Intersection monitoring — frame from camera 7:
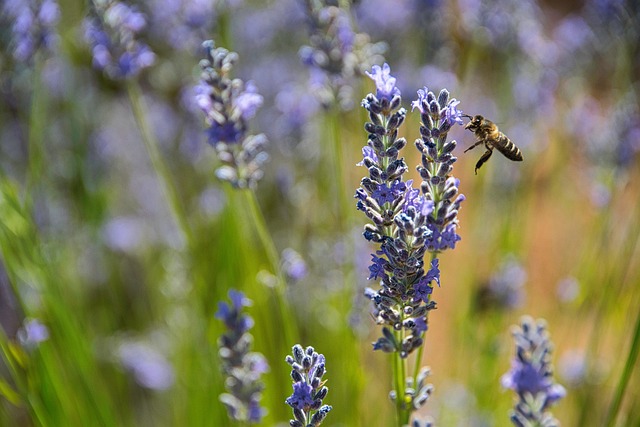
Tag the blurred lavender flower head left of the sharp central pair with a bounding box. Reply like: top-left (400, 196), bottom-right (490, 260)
top-left (195, 40), bottom-right (269, 188)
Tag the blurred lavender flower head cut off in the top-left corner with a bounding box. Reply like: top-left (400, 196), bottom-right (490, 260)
top-left (1, 0), bottom-right (60, 63)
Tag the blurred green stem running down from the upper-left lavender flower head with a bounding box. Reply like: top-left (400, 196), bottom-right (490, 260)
top-left (127, 80), bottom-right (193, 246)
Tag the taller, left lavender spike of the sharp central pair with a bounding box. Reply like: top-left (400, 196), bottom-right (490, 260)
top-left (356, 64), bottom-right (440, 358)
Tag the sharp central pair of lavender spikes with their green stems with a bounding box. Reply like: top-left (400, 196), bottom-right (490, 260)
top-left (355, 64), bottom-right (464, 426)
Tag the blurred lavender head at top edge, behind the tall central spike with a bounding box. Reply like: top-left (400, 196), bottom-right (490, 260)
top-left (300, 0), bottom-right (386, 109)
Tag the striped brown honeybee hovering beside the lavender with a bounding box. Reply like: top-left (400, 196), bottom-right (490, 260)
top-left (463, 114), bottom-right (522, 175)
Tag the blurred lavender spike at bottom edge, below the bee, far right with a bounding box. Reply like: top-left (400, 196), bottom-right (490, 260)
top-left (501, 316), bottom-right (566, 427)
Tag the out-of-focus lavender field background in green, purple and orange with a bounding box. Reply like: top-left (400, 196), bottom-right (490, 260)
top-left (0, 0), bottom-right (640, 426)
